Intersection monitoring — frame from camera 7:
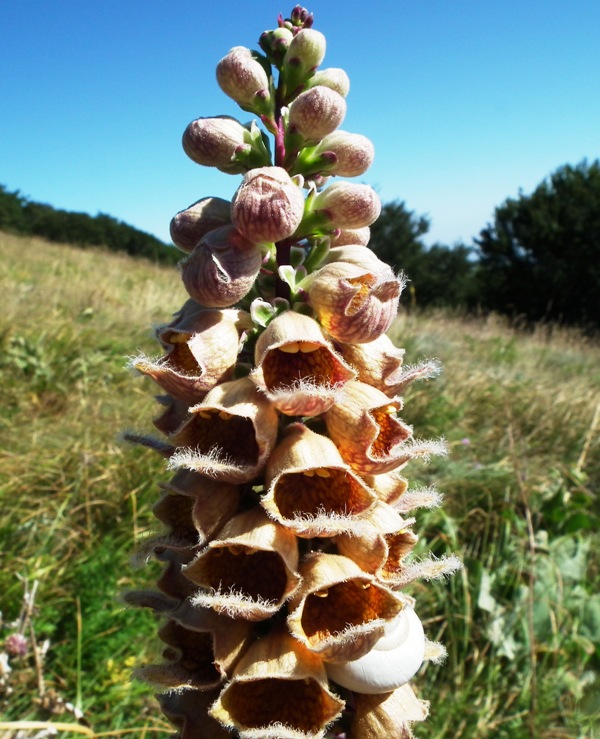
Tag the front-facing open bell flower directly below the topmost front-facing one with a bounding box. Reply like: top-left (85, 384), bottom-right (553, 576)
top-left (261, 423), bottom-right (376, 538)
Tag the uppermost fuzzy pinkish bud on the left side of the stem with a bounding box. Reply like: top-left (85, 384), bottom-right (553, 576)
top-left (217, 46), bottom-right (272, 113)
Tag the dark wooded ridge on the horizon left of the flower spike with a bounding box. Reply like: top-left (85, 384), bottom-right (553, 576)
top-left (0, 185), bottom-right (182, 264)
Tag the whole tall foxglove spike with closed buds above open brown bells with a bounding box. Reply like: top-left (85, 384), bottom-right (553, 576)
top-left (127, 6), bottom-right (459, 739)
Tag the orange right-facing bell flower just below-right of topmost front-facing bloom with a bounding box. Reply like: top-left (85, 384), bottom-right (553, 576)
top-left (325, 380), bottom-right (412, 475)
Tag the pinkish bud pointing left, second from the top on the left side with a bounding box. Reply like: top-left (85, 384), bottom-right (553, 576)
top-left (182, 115), bottom-right (252, 174)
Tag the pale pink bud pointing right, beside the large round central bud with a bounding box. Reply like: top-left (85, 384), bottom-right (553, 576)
top-left (311, 182), bottom-right (381, 228)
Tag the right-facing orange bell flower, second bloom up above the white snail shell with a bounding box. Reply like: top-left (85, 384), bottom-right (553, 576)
top-left (335, 502), bottom-right (418, 585)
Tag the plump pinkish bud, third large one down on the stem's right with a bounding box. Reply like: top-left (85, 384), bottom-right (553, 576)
top-left (289, 86), bottom-right (346, 142)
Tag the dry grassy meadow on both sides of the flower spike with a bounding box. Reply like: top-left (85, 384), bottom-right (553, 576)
top-left (0, 234), bottom-right (600, 739)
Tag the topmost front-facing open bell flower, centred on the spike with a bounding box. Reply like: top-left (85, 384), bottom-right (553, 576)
top-left (250, 311), bottom-right (356, 416)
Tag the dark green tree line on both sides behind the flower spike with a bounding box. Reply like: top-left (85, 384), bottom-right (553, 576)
top-left (0, 160), bottom-right (600, 330)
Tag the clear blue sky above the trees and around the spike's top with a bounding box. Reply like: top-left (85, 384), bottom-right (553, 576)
top-left (0, 0), bottom-right (600, 245)
